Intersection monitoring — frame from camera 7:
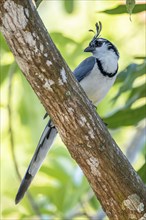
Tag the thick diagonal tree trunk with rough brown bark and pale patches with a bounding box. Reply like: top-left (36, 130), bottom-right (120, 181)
top-left (0, 0), bottom-right (146, 220)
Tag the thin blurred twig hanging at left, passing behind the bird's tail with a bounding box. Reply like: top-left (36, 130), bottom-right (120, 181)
top-left (7, 62), bottom-right (41, 219)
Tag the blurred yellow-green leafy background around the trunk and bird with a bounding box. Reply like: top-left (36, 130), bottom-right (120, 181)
top-left (0, 0), bottom-right (146, 220)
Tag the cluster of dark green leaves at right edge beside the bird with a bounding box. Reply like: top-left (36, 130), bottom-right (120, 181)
top-left (105, 61), bottom-right (146, 129)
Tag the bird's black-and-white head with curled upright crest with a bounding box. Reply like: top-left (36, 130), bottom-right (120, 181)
top-left (84, 22), bottom-right (119, 59)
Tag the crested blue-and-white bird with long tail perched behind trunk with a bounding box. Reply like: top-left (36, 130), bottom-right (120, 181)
top-left (15, 21), bottom-right (119, 204)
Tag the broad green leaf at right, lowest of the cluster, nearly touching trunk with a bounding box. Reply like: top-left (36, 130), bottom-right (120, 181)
top-left (104, 105), bottom-right (146, 129)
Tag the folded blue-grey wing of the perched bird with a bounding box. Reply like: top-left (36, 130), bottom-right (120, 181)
top-left (73, 57), bottom-right (96, 82)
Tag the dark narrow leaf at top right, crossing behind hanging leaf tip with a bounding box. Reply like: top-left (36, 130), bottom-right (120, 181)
top-left (101, 4), bottom-right (146, 15)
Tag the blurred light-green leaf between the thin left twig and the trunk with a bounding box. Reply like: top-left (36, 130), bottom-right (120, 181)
top-left (18, 74), bottom-right (46, 143)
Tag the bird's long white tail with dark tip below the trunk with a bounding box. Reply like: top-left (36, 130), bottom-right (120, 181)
top-left (15, 120), bottom-right (57, 204)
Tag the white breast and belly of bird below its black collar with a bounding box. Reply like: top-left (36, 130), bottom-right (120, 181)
top-left (80, 65), bottom-right (116, 105)
